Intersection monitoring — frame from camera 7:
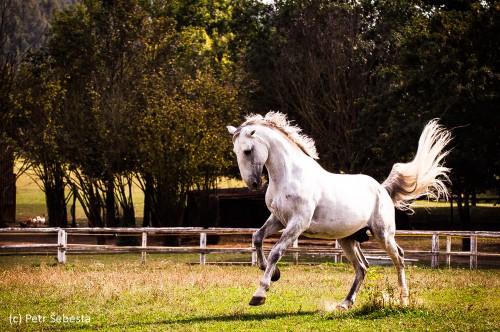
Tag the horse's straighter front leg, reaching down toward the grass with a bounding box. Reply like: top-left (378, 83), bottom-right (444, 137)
top-left (249, 223), bottom-right (305, 305)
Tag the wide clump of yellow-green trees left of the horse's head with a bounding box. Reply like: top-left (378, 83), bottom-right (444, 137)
top-left (10, 0), bottom-right (246, 226)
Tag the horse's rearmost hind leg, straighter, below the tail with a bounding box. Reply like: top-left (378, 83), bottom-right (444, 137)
top-left (374, 232), bottom-right (409, 306)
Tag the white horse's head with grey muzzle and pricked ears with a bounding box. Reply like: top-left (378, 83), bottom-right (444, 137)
top-left (227, 126), bottom-right (269, 190)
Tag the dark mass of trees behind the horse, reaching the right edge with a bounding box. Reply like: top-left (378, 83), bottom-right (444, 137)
top-left (240, 0), bottom-right (500, 223)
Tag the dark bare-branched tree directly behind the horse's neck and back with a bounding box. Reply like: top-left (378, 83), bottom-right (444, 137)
top-left (246, 0), bottom-right (422, 176)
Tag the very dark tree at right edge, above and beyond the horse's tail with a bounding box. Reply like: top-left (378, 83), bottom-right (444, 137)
top-left (391, 1), bottom-right (500, 228)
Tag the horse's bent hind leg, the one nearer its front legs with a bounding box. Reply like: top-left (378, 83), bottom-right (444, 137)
top-left (337, 237), bottom-right (368, 309)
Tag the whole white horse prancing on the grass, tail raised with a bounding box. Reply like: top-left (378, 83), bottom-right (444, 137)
top-left (227, 112), bottom-right (451, 309)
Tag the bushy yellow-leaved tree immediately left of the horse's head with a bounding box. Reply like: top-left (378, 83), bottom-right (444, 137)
top-left (139, 63), bottom-right (238, 226)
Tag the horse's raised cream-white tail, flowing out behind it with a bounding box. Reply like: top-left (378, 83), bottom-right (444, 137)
top-left (382, 120), bottom-right (451, 211)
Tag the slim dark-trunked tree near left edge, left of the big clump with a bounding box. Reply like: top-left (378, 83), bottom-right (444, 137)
top-left (13, 56), bottom-right (68, 227)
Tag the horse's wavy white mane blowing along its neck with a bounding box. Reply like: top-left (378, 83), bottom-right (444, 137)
top-left (241, 112), bottom-right (319, 159)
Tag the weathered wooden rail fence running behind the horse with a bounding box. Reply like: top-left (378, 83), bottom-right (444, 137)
top-left (0, 227), bottom-right (500, 269)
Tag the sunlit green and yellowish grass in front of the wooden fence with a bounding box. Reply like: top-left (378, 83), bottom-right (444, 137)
top-left (0, 255), bottom-right (500, 331)
